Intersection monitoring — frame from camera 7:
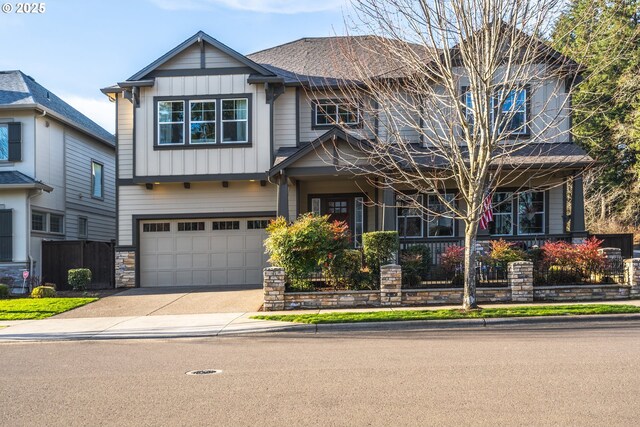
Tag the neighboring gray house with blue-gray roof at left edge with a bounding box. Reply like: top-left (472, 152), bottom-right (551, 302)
top-left (0, 71), bottom-right (116, 282)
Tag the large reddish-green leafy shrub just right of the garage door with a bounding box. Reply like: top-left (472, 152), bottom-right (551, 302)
top-left (265, 214), bottom-right (349, 290)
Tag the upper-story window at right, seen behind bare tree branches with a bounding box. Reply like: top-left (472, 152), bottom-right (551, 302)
top-left (463, 87), bottom-right (530, 135)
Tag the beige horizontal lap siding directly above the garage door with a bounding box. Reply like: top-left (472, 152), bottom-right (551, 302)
top-left (118, 181), bottom-right (278, 246)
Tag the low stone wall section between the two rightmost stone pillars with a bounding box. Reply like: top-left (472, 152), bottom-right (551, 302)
top-left (533, 285), bottom-right (630, 301)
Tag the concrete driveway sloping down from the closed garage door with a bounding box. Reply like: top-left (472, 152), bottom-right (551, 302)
top-left (56, 286), bottom-right (263, 319)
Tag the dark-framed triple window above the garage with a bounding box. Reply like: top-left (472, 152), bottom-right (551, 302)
top-left (155, 94), bottom-right (251, 149)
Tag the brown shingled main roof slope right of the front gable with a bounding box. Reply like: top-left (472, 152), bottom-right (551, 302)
top-left (247, 35), bottom-right (428, 86)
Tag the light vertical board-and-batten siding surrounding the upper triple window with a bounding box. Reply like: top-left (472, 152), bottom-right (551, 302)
top-left (135, 74), bottom-right (271, 176)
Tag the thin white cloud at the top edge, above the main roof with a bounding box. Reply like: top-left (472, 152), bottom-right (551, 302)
top-left (149, 0), bottom-right (347, 15)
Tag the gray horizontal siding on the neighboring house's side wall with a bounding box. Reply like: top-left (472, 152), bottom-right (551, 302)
top-left (65, 130), bottom-right (116, 240)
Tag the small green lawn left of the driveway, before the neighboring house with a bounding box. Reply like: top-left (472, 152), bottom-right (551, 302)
top-left (0, 298), bottom-right (98, 320)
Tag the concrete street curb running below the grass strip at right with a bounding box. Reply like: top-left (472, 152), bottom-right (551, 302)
top-left (261, 313), bottom-right (640, 333)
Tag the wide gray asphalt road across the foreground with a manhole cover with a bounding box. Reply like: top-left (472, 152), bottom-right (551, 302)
top-left (0, 321), bottom-right (640, 426)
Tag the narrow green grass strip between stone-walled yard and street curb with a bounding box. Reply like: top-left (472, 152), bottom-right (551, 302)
top-left (251, 304), bottom-right (640, 325)
